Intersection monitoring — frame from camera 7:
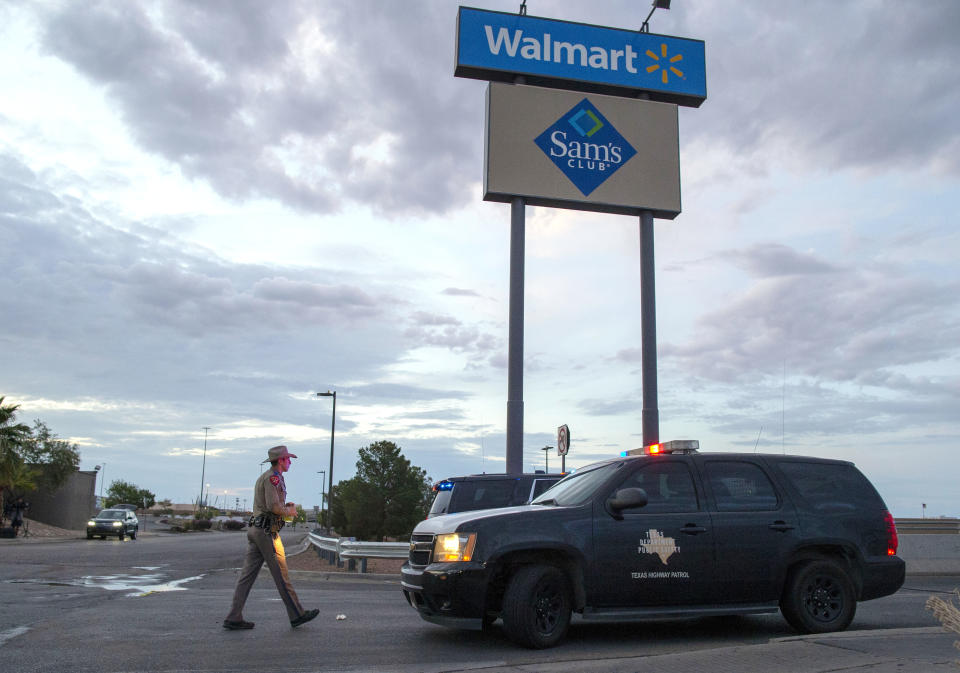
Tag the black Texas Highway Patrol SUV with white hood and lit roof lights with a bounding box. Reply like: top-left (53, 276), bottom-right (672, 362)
top-left (401, 440), bottom-right (905, 648)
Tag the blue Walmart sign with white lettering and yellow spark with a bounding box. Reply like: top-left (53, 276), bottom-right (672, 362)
top-left (454, 7), bottom-right (707, 107)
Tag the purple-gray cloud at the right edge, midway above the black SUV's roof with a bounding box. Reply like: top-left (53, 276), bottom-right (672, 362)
top-left (660, 246), bottom-right (960, 381)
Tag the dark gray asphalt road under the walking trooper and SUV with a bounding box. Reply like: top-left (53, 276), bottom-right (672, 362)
top-left (0, 531), bottom-right (960, 673)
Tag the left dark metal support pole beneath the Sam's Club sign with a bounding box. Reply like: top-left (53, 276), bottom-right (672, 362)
top-left (506, 196), bottom-right (526, 474)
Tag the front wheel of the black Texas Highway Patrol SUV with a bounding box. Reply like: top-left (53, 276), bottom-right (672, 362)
top-left (501, 565), bottom-right (571, 649)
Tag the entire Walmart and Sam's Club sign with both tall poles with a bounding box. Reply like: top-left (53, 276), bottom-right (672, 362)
top-left (454, 0), bottom-right (707, 473)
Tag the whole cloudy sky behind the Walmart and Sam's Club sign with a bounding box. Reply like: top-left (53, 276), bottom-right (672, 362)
top-left (0, 0), bottom-right (960, 516)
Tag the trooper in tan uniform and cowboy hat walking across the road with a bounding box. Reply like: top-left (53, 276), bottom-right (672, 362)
top-left (223, 446), bottom-right (320, 630)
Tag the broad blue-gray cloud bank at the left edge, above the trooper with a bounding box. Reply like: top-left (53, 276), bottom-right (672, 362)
top-left (0, 155), bottom-right (404, 406)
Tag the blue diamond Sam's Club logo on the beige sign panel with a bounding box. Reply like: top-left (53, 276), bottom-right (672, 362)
top-left (534, 98), bottom-right (637, 196)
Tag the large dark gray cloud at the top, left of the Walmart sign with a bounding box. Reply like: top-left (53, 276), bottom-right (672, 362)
top-left (37, 2), bottom-right (482, 214)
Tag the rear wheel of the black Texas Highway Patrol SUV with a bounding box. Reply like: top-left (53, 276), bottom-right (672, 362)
top-left (780, 561), bottom-right (857, 633)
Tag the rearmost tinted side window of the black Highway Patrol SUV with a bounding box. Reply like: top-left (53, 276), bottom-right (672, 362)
top-left (779, 461), bottom-right (884, 510)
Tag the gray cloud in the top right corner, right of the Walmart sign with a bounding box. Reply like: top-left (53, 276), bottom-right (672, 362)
top-left (680, 0), bottom-right (960, 174)
